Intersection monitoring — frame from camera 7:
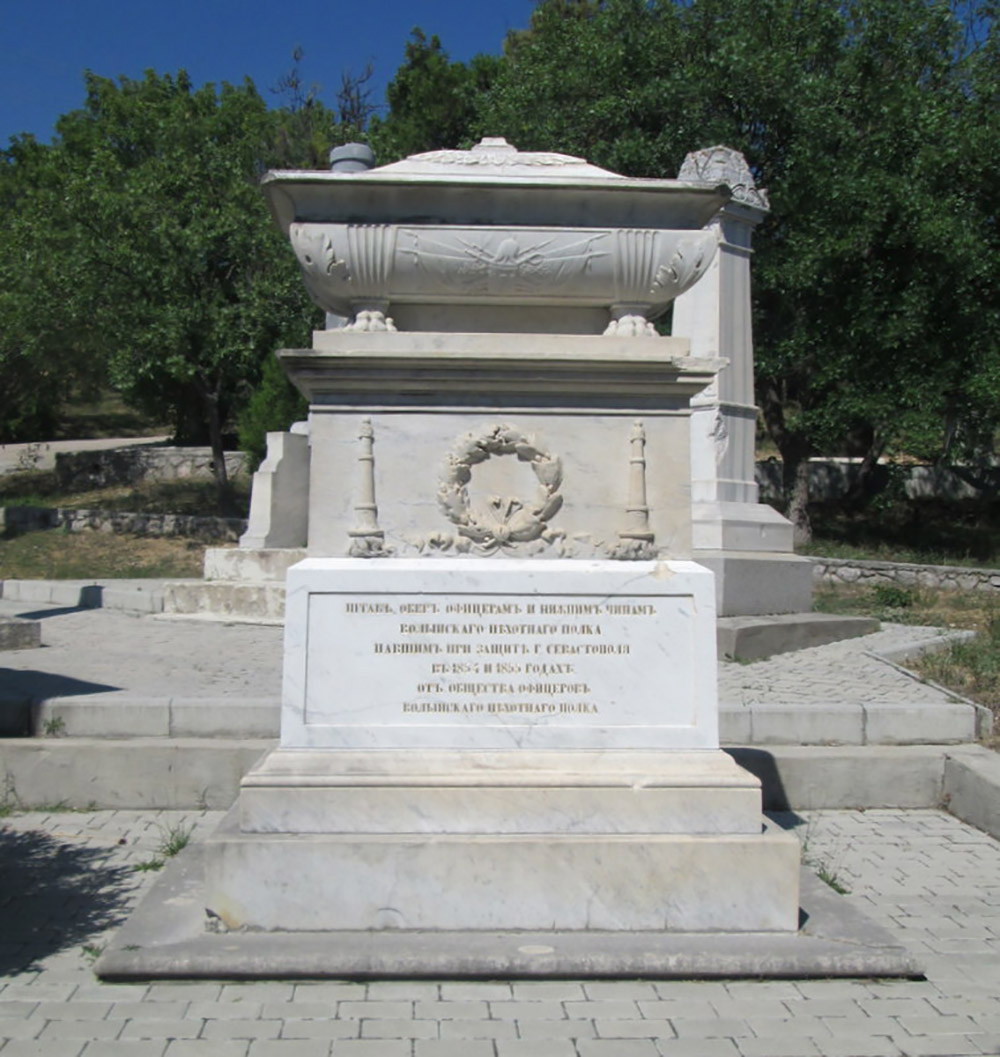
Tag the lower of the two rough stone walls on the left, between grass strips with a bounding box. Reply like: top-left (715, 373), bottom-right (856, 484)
top-left (0, 506), bottom-right (246, 542)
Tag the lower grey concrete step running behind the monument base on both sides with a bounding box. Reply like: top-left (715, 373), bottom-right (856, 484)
top-left (0, 737), bottom-right (1000, 811)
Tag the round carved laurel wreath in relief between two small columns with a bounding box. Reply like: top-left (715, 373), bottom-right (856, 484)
top-left (438, 426), bottom-right (562, 550)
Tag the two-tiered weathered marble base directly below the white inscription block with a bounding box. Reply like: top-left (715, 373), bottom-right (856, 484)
top-left (205, 749), bottom-right (799, 932)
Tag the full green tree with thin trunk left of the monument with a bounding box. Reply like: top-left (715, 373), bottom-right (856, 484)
top-left (46, 72), bottom-right (315, 503)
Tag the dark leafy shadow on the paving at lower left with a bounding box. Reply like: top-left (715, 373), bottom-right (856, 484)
top-left (0, 826), bottom-right (134, 975)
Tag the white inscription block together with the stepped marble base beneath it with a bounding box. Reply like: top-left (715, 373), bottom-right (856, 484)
top-left (205, 558), bottom-right (799, 932)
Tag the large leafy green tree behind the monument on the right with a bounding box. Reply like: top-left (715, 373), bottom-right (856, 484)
top-left (474, 0), bottom-right (1000, 535)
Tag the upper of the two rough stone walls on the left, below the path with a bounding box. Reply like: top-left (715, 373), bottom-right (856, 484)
top-left (55, 445), bottom-right (246, 490)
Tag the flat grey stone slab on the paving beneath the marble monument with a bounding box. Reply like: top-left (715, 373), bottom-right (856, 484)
top-left (96, 845), bottom-right (923, 981)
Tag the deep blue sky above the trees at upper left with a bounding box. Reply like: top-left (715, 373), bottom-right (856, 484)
top-left (0, 0), bottom-right (535, 147)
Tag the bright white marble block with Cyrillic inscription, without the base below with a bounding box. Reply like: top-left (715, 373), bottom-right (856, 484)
top-left (282, 562), bottom-right (716, 748)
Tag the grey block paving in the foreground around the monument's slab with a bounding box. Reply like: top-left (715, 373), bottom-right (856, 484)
top-left (0, 811), bottom-right (1000, 1057)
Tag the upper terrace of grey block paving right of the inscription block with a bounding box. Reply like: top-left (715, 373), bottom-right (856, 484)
top-left (719, 624), bottom-right (953, 705)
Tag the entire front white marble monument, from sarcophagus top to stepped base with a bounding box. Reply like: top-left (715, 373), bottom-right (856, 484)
top-left (205, 140), bottom-right (799, 951)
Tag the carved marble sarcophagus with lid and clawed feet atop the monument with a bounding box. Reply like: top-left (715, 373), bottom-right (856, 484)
top-left (263, 138), bottom-right (730, 335)
